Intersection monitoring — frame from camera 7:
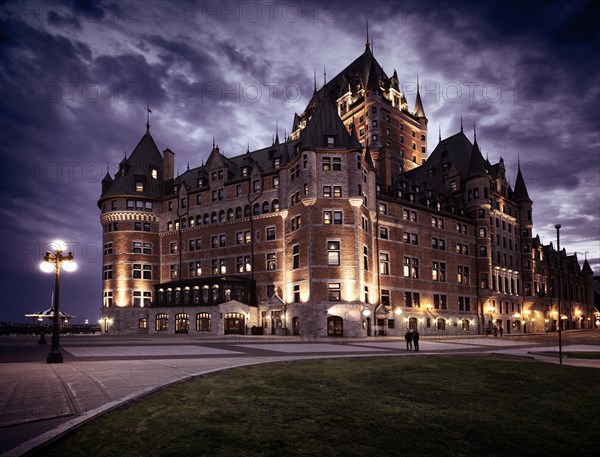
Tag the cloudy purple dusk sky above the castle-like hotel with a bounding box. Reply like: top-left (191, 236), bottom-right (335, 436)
top-left (0, 0), bottom-right (600, 323)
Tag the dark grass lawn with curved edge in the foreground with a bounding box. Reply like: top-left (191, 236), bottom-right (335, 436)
top-left (37, 356), bottom-right (600, 457)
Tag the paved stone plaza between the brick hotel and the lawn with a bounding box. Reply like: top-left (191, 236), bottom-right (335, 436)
top-left (0, 332), bottom-right (600, 456)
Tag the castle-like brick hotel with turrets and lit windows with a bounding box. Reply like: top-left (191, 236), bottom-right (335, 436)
top-left (98, 43), bottom-right (593, 338)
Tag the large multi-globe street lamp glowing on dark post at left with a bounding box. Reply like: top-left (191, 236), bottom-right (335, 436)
top-left (40, 241), bottom-right (77, 363)
